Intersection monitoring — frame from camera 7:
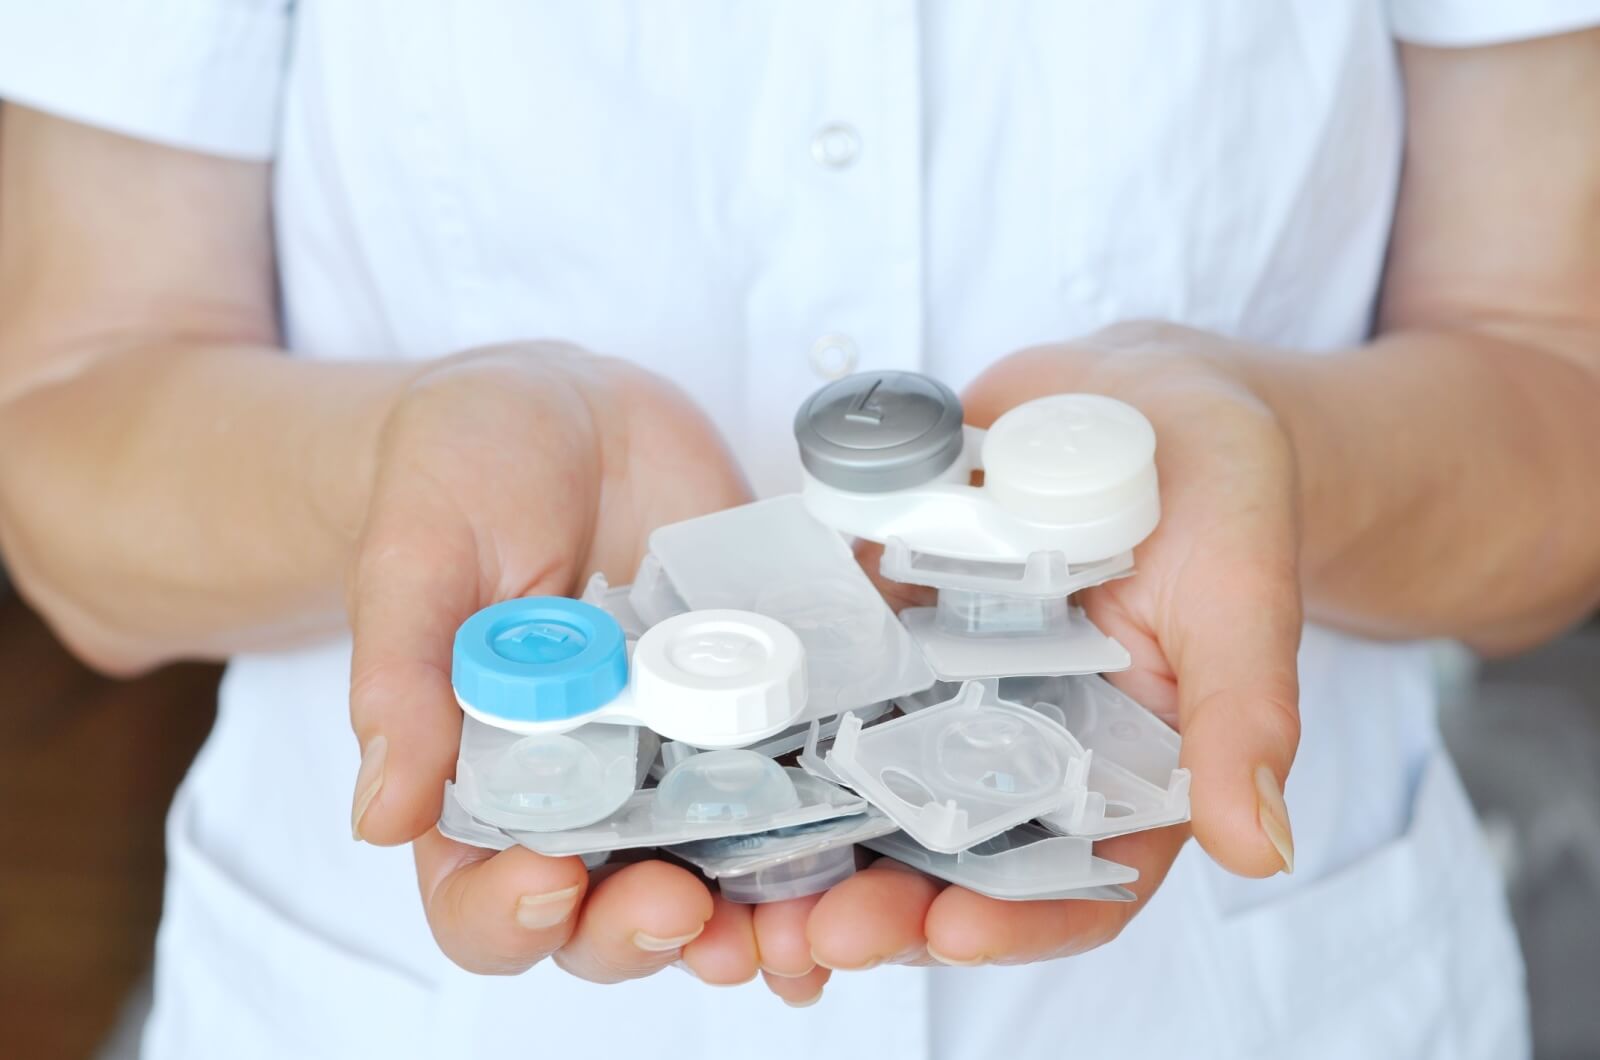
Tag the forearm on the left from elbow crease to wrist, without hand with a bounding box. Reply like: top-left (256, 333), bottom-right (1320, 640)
top-left (0, 341), bottom-right (408, 671)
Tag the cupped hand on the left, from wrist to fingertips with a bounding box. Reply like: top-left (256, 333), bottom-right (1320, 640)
top-left (349, 344), bottom-right (758, 983)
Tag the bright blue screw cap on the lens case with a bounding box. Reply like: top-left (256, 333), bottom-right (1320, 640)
top-left (450, 596), bottom-right (627, 722)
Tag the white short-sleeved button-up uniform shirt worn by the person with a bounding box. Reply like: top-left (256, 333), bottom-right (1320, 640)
top-left (0, 0), bottom-right (1600, 1060)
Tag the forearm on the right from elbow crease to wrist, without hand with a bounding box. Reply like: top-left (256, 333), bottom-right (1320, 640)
top-left (1240, 323), bottom-right (1600, 650)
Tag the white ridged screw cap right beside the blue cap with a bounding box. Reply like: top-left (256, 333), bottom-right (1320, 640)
top-left (632, 610), bottom-right (806, 748)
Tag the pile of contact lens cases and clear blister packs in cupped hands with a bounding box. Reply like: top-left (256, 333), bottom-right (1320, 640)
top-left (440, 371), bottom-right (1189, 901)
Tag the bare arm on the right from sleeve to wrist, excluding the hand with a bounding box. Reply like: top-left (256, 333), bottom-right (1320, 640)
top-left (1251, 30), bottom-right (1600, 650)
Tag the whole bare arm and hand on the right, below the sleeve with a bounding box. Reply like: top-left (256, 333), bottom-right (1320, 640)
top-left (806, 32), bottom-right (1600, 967)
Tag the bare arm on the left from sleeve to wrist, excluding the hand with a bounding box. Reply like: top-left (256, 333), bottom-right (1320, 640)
top-left (0, 107), bottom-right (406, 671)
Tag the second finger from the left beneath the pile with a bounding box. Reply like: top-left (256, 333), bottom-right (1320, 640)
top-left (554, 861), bottom-right (715, 983)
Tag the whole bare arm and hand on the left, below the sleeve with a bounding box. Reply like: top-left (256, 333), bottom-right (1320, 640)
top-left (0, 110), bottom-right (774, 982)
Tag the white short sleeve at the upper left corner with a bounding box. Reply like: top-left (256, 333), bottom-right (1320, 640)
top-left (0, 0), bottom-right (291, 160)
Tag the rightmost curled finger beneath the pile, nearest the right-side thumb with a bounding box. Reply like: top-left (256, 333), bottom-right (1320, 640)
top-left (925, 828), bottom-right (1187, 967)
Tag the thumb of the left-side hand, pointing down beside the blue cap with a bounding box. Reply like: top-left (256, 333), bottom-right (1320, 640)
top-left (350, 493), bottom-right (478, 844)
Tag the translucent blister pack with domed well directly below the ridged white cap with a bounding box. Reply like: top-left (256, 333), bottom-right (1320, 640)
top-left (512, 751), bottom-right (867, 857)
